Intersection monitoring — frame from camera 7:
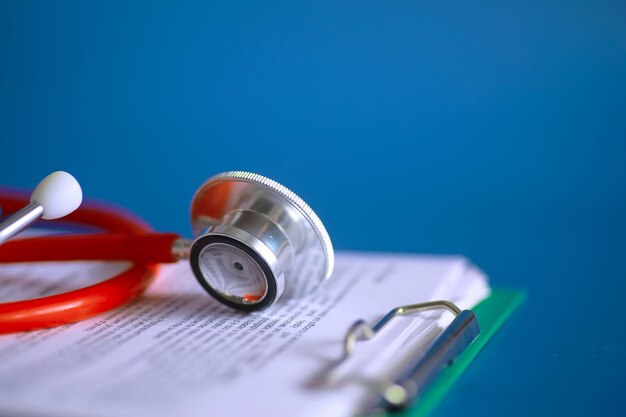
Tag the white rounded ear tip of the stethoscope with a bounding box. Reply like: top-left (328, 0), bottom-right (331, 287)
top-left (30, 171), bottom-right (83, 220)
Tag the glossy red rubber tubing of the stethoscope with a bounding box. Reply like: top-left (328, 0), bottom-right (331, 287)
top-left (0, 190), bottom-right (179, 334)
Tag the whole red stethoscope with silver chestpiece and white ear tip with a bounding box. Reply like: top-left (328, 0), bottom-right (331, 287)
top-left (0, 171), bottom-right (334, 333)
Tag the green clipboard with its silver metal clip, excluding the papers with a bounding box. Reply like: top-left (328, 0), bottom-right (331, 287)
top-left (343, 289), bottom-right (526, 417)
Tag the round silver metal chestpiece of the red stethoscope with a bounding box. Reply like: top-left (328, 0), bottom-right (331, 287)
top-left (189, 171), bottom-right (334, 311)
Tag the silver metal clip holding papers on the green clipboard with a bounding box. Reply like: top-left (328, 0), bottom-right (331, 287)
top-left (344, 300), bottom-right (480, 414)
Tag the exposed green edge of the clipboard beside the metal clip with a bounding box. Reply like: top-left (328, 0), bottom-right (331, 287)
top-left (387, 289), bottom-right (527, 417)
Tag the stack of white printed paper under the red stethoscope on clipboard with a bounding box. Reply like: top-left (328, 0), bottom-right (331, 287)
top-left (0, 252), bottom-right (489, 417)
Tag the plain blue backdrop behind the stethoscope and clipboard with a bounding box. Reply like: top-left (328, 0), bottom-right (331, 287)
top-left (0, 0), bottom-right (626, 416)
